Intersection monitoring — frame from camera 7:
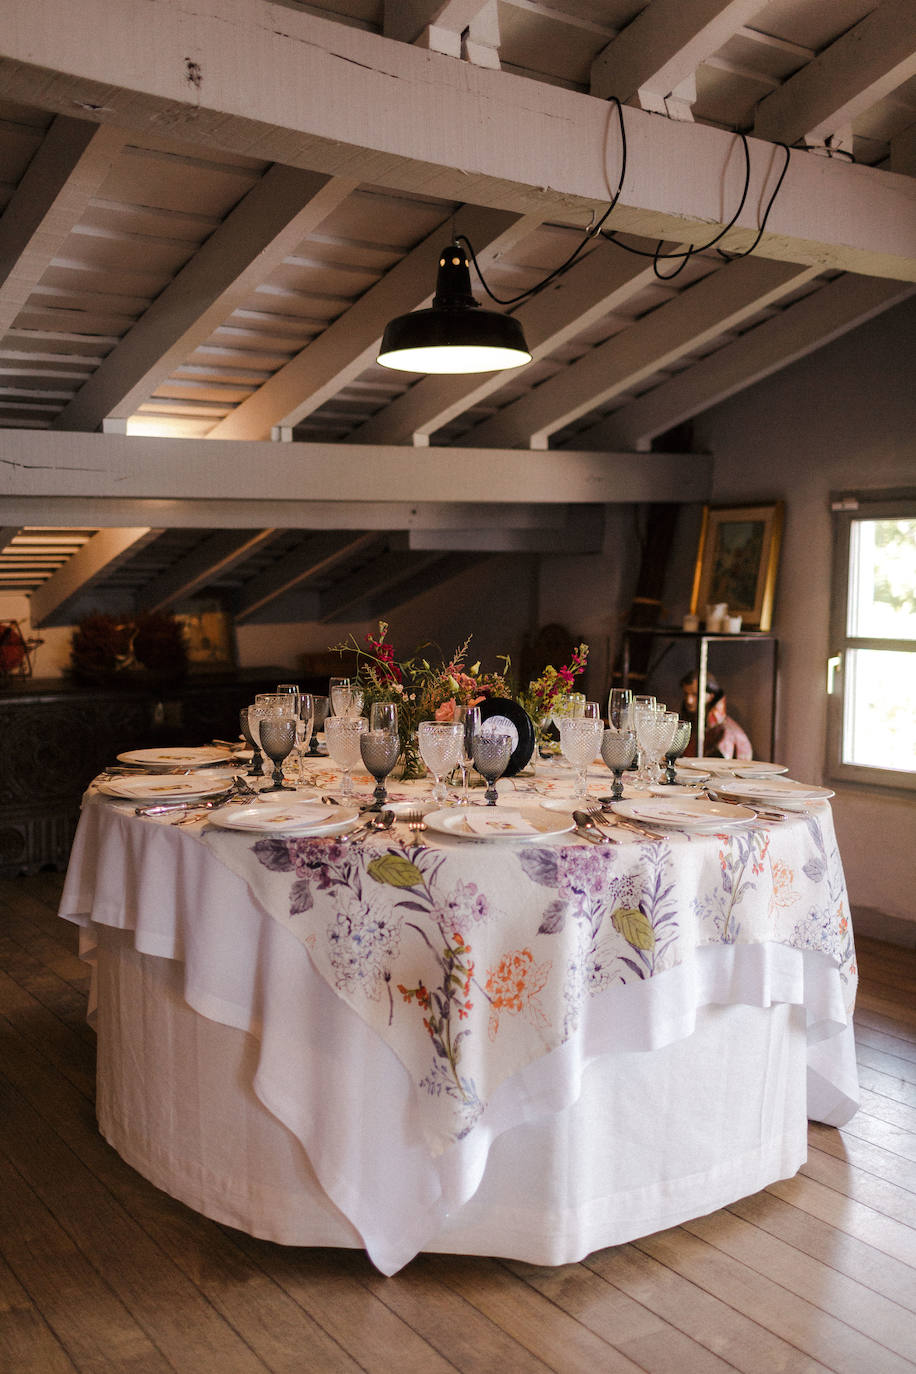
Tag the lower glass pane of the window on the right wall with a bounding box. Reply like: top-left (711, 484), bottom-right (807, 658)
top-left (843, 649), bottom-right (916, 772)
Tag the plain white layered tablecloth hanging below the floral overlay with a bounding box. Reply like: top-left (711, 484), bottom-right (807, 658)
top-left (60, 800), bottom-right (857, 1274)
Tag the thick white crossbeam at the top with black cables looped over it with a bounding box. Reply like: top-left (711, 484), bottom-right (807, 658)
top-left (0, 0), bottom-right (916, 279)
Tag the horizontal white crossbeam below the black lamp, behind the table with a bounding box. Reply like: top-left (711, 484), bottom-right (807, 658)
top-left (0, 430), bottom-right (713, 505)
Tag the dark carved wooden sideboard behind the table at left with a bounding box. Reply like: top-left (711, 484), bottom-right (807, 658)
top-left (0, 668), bottom-right (288, 878)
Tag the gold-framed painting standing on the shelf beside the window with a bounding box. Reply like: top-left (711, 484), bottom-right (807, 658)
top-left (691, 502), bottom-right (786, 631)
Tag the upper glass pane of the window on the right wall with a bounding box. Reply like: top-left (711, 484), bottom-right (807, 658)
top-left (846, 519), bottom-right (916, 639)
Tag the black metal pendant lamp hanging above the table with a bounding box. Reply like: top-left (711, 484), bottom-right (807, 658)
top-left (378, 243), bottom-right (531, 372)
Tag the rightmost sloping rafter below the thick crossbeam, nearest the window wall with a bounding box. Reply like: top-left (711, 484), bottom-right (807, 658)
top-left (575, 275), bottom-right (916, 449)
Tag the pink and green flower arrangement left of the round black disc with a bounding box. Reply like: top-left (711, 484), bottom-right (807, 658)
top-left (334, 620), bottom-right (509, 778)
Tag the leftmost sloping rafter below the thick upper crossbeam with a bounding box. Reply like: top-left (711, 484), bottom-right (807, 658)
top-left (0, 114), bottom-right (126, 335)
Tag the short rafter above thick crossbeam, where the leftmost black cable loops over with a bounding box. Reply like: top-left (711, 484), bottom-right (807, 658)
top-left (591, 0), bottom-right (764, 103)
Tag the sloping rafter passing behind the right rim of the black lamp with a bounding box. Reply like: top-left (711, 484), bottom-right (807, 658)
top-left (350, 243), bottom-right (654, 444)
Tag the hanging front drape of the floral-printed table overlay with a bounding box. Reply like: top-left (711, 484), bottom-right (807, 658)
top-left (202, 811), bottom-right (856, 1153)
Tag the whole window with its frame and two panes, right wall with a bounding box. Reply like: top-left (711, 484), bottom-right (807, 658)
top-left (828, 491), bottom-right (916, 789)
